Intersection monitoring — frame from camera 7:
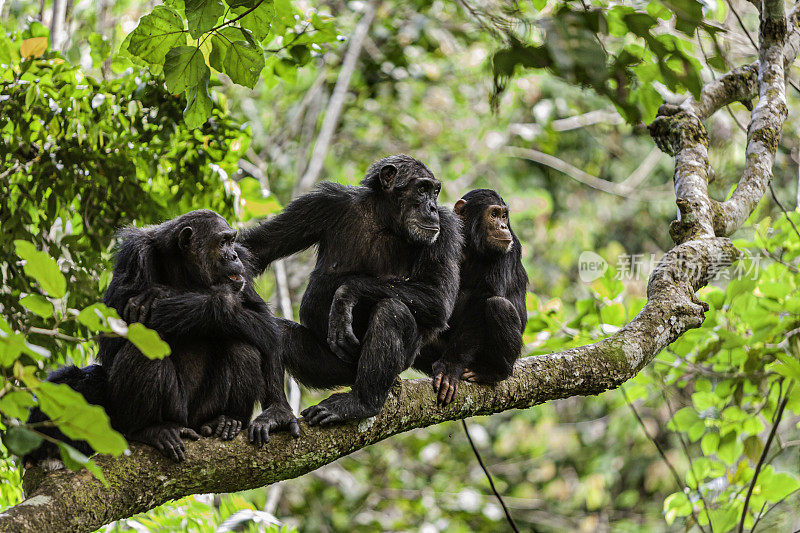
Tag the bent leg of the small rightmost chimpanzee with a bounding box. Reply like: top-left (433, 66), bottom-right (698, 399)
top-left (464, 296), bottom-right (522, 383)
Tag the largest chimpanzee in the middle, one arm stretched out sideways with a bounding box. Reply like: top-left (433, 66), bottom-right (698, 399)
top-left (240, 155), bottom-right (461, 428)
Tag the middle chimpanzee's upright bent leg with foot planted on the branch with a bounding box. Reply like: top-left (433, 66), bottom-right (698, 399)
top-left (303, 298), bottom-right (419, 425)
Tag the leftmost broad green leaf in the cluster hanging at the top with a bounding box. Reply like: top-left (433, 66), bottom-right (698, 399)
top-left (128, 6), bottom-right (186, 65)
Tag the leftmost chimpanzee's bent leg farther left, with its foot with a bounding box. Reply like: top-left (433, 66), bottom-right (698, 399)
top-left (108, 343), bottom-right (200, 461)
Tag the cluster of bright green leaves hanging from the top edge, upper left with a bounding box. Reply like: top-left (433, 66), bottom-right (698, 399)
top-left (121, 0), bottom-right (336, 128)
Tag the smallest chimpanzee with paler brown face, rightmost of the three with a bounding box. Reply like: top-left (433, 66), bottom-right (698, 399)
top-left (414, 189), bottom-right (528, 405)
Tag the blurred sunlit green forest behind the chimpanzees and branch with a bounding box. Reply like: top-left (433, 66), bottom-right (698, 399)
top-left (0, 0), bottom-right (800, 533)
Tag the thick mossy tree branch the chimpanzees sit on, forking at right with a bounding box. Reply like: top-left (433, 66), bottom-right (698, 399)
top-left (0, 0), bottom-right (800, 532)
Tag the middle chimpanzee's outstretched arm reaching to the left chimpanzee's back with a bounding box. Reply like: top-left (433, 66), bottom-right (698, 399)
top-left (237, 182), bottom-right (353, 272)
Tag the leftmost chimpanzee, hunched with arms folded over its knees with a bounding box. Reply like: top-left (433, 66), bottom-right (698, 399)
top-left (94, 210), bottom-right (299, 460)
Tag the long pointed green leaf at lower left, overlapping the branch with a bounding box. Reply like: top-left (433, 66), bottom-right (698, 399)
top-left (25, 379), bottom-right (128, 455)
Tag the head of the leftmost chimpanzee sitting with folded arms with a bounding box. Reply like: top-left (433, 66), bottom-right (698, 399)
top-left (179, 214), bottom-right (246, 291)
